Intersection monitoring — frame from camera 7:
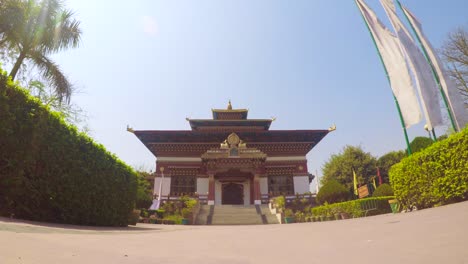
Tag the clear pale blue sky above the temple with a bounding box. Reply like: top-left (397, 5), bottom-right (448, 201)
top-left (51, 0), bottom-right (468, 190)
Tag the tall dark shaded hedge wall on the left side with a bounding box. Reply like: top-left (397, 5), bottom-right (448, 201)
top-left (0, 70), bottom-right (137, 226)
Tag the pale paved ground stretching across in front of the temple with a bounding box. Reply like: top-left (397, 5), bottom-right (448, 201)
top-left (0, 202), bottom-right (468, 264)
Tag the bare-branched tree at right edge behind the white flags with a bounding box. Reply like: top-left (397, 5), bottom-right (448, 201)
top-left (442, 27), bottom-right (468, 101)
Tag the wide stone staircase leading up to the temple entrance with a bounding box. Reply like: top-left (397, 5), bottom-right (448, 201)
top-left (195, 205), bottom-right (278, 225)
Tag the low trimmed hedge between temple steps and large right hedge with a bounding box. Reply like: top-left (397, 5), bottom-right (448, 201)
top-left (311, 196), bottom-right (395, 217)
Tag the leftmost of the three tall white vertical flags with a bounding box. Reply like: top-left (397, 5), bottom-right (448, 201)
top-left (356, 0), bottom-right (421, 128)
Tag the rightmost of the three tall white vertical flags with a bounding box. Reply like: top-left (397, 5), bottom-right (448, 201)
top-left (402, 1), bottom-right (468, 130)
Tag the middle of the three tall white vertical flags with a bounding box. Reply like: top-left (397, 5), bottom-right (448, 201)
top-left (380, 0), bottom-right (443, 130)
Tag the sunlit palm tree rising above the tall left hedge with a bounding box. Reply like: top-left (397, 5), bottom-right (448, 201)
top-left (0, 0), bottom-right (81, 101)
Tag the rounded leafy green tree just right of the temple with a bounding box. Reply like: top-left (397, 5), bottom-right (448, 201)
top-left (321, 146), bottom-right (377, 191)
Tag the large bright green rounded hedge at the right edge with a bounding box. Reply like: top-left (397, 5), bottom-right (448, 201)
top-left (390, 127), bottom-right (468, 208)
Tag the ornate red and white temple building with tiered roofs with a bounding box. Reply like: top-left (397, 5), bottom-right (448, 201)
top-left (132, 102), bottom-right (333, 205)
